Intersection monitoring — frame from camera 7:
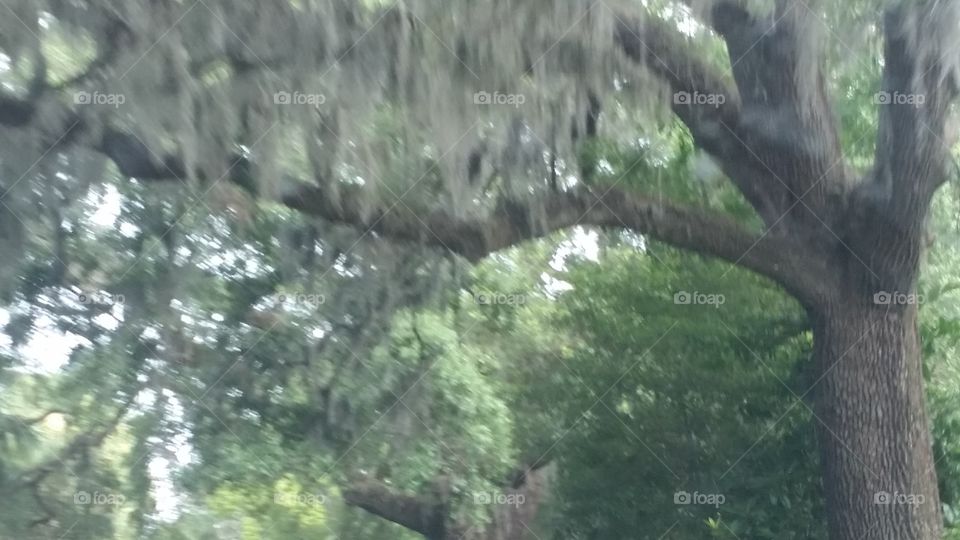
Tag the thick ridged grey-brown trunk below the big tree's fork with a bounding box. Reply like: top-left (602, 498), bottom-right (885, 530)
top-left (814, 294), bottom-right (942, 540)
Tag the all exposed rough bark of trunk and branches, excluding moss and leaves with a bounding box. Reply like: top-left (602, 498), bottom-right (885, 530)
top-left (0, 0), bottom-right (957, 540)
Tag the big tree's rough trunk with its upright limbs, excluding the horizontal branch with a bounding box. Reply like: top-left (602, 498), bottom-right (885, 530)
top-left (621, 1), bottom-right (956, 540)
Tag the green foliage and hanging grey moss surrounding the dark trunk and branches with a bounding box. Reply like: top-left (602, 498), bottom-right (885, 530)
top-left (0, 0), bottom-right (960, 540)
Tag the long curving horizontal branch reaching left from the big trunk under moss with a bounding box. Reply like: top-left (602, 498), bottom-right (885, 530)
top-left (283, 187), bottom-right (827, 300)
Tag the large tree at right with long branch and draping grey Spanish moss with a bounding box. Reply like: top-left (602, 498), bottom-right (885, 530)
top-left (0, 0), bottom-right (958, 539)
